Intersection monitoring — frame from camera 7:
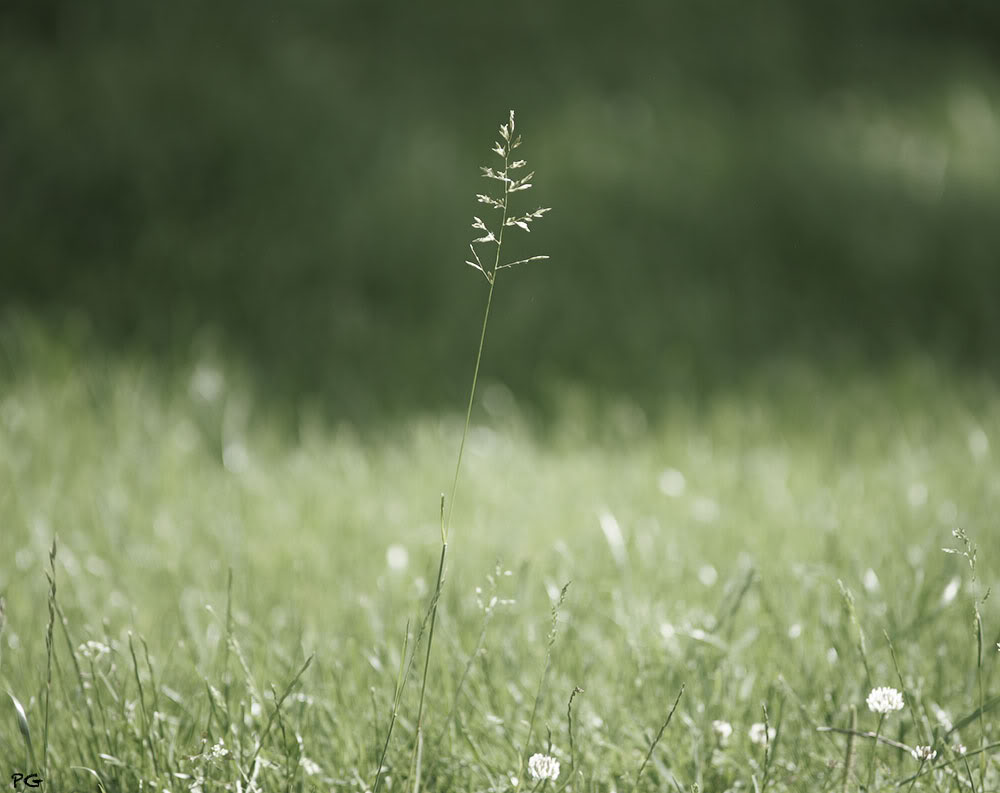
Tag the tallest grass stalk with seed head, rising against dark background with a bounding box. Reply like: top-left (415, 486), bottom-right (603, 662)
top-left (413, 110), bottom-right (549, 793)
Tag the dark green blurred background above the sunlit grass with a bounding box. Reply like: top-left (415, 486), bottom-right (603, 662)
top-left (0, 0), bottom-right (1000, 418)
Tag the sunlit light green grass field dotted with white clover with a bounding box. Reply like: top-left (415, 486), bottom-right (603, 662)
top-left (0, 310), bottom-right (1000, 793)
